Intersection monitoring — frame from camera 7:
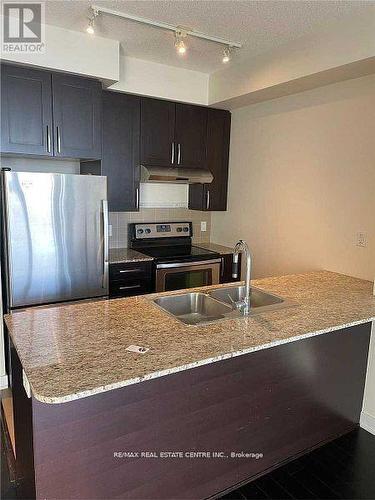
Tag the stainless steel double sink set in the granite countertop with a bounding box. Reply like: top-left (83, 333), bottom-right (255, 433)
top-left (153, 286), bottom-right (294, 325)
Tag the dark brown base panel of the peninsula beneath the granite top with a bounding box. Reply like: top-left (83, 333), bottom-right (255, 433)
top-left (10, 323), bottom-right (371, 500)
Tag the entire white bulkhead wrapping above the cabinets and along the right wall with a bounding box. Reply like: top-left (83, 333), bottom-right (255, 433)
top-left (0, 16), bottom-right (375, 109)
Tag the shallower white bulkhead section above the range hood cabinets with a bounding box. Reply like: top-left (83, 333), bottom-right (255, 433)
top-left (109, 56), bottom-right (208, 104)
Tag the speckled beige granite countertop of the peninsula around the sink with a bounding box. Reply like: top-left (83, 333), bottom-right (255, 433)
top-left (5, 271), bottom-right (375, 403)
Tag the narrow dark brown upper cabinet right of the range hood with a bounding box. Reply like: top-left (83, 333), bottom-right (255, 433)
top-left (189, 109), bottom-right (231, 211)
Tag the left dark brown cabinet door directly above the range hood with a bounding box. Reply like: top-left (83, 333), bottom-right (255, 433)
top-left (141, 98), bottom-right (176, 167)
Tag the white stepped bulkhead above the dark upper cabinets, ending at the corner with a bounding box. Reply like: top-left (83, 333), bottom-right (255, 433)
top-left (0, 24), bottom-right (209, 105)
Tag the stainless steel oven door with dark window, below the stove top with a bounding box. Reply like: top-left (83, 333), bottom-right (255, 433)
top-left (156, 259), bottom-right (221, 292)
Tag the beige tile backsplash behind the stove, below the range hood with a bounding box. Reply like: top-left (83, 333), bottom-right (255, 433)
top-left (109, 208), bottom-right (211, 248)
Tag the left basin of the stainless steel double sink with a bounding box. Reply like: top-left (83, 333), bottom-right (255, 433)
top-left (154, 293), bottom-right (232, 325)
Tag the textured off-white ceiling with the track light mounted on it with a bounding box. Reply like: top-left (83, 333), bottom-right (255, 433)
top-left (46, 0), bottom-right (375, 73)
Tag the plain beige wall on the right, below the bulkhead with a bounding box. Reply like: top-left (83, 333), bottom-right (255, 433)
top-left (212, 76), bottom-right (375, 279)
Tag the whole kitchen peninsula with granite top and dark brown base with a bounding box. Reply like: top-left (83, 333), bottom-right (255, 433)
top-left (6, 271), bottom-right (375, 499)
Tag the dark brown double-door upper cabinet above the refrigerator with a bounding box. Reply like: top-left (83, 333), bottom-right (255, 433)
top-left (1, 65), bottom-right (102, 159)
